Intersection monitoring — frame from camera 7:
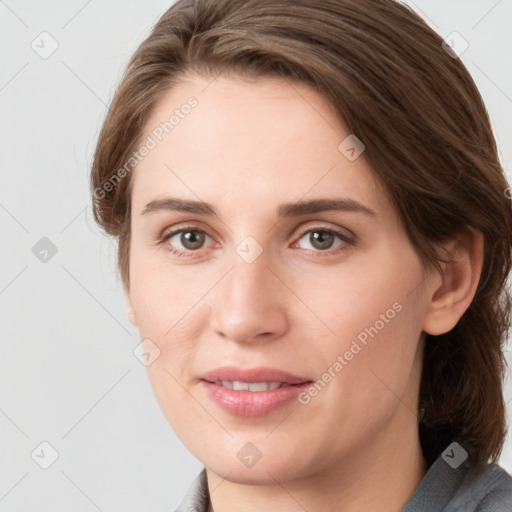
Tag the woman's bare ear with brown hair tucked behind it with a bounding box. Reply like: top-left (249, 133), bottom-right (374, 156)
top-left (423, 228), bottom-right (484, 335)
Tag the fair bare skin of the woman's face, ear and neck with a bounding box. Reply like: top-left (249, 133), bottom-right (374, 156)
top-left (125, 75), bottom-right (483, 512)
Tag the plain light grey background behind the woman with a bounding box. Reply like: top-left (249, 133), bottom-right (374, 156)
top-left (0, 0), bottom-right (512, 512)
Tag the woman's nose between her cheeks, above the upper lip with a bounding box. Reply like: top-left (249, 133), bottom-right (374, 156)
top-left (211, 245), bottom-right (290, 343)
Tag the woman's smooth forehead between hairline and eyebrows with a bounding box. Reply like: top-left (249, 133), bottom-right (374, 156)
top-left (132, 75), bottom-right (389, 217)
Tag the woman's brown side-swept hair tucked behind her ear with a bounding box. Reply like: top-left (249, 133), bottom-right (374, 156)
top-left (91, 0), bottom-right (512, 470)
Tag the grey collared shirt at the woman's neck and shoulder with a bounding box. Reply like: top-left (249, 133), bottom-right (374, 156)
top-left (174, 455), bottom-right (512, 512)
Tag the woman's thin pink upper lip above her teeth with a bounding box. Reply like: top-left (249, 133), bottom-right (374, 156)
top-left (200, 366), bottom-right (311, 384)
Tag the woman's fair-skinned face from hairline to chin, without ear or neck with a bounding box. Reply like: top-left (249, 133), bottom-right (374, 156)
top-left (127, 75), bottom-right (427, 483)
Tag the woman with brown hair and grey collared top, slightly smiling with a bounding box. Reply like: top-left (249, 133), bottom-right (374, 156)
top-left (92, 0), bottom-right (512, 512)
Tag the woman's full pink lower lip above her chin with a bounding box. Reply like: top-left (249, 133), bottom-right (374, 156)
top-left (201, 380), bottom-right (311, 417)
